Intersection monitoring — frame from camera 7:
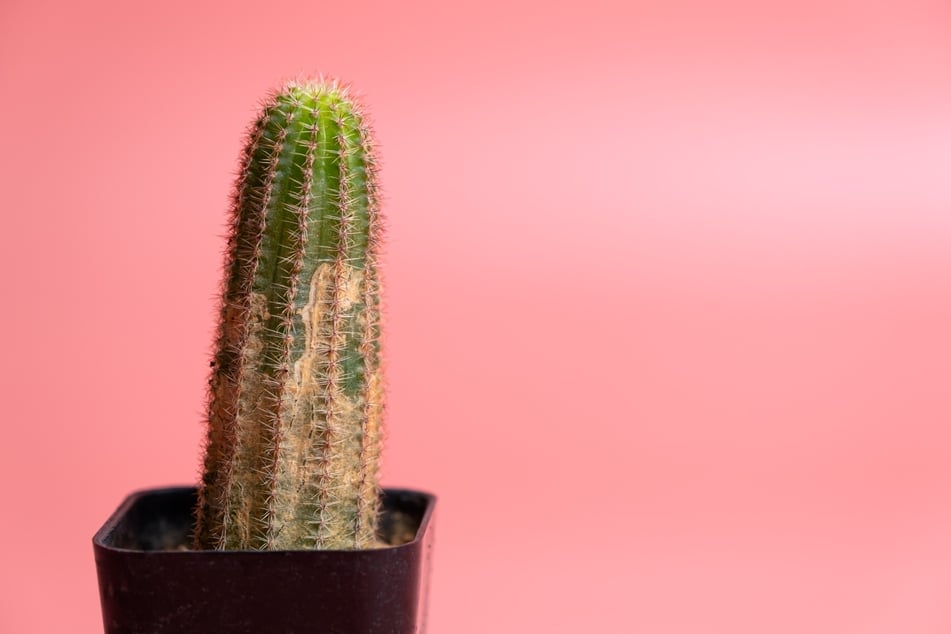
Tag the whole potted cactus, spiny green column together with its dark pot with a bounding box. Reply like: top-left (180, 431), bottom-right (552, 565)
top-left (93, 81), bottom-right (435, 634)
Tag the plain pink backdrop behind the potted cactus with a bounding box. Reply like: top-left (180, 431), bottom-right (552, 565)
top-left (0, 0), bottom-right (951, 634)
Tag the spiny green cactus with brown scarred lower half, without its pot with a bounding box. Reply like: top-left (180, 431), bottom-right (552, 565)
top-left (195, 81), bottom-right (383, 550)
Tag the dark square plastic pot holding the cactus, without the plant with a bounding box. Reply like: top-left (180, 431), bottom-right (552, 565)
top-left (93, 487), bottom-right (436, 634)
